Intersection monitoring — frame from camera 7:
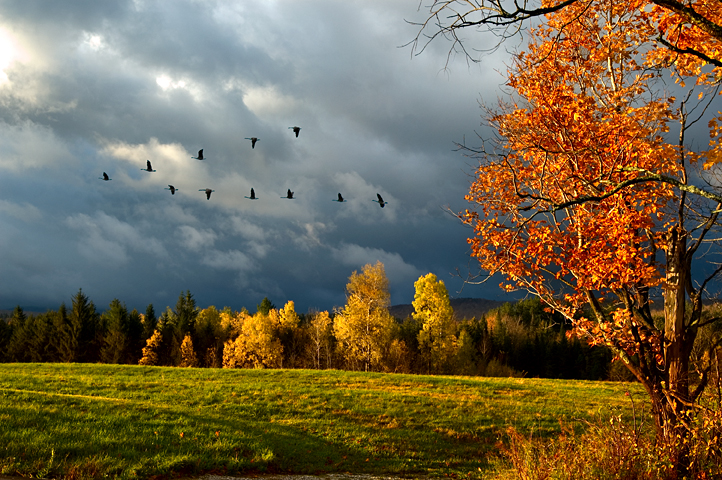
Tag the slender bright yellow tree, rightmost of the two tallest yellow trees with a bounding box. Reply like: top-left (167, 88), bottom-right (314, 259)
top-left (413, 273), bottom-right (456, 372)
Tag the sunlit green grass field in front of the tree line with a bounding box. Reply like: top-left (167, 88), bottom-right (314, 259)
top-left (0, 364), bottom-right (641, 479)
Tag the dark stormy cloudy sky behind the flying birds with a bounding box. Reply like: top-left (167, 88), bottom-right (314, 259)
top-left (0, 0), bottom-right (509, 312)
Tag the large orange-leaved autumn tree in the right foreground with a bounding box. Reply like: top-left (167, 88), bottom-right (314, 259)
top-left (422, 0), bottom-right (722, 468)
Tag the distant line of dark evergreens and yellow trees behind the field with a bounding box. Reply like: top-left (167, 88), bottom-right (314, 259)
top-left (0, 262), bottom-right (614, 380)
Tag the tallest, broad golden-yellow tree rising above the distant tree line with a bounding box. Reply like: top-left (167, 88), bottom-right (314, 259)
top-left (333, 261), bottom-right (393, 371)
